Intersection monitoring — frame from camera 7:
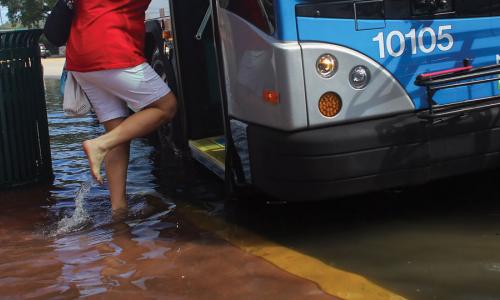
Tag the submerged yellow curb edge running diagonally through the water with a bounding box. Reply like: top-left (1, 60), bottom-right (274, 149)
top-left (177, 204), bottom-right (405, 300)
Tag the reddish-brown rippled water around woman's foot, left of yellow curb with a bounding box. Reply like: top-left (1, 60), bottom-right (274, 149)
top-left (0, 80), bottom-right (332, 299)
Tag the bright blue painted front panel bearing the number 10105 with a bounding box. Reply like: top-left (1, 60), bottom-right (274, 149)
top-left (297, 17), bottom-right (500, 109)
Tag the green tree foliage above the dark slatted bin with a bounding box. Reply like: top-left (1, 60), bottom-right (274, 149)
top-left (0, 0), bottom-right (57, 28)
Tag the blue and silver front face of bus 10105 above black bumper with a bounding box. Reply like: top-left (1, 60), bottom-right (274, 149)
top-left (294, 0), bottom-right (500, 126)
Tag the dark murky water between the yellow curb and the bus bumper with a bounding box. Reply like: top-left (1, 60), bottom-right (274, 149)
top-left (214, 171), bottom-right (500, 299)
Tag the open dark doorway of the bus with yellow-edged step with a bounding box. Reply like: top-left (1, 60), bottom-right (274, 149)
top-left (170, 0), bottom-right (229, 177)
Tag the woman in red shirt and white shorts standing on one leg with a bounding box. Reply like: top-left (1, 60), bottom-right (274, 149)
top-left (66, 0), bottom-right (176, 211)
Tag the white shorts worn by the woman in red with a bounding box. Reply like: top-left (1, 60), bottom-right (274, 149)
top-left (71, 63), bottom-right (170, 123)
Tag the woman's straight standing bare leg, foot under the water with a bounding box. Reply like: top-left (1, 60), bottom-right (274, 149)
top-left (103, 118), bottom-right (130, 212)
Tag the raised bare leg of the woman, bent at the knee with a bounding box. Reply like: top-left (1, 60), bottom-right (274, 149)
top-left (83, 93), bottom-right (177, 184)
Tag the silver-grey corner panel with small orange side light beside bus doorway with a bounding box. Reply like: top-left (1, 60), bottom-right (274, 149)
top-left (219, 9), bottom-right (308, 130)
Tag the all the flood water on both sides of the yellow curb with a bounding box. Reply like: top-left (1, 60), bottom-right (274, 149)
top-left (0, 80), bottom-right (500, 300)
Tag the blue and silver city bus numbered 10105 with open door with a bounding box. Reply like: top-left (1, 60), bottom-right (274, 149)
top-left (147, 0), bottom-right (500, 201)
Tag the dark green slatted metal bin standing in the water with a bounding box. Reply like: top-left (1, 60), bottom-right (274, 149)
top-left (0, 30), bottom-right (53, 188)
